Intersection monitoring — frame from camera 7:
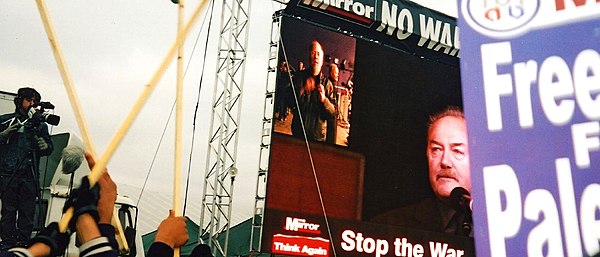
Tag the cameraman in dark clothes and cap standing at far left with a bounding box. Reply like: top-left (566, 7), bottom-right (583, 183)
top-left (0, 87), bottom-right (54, 249)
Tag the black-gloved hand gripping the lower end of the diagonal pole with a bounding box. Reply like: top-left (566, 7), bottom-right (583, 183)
top-left (63, 176), bottom-right (100, 231)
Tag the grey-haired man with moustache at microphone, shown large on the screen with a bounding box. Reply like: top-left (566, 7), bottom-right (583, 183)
top-left (372, 107), bottom-right (472, 236)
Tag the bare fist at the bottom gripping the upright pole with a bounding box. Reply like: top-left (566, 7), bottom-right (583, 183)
top-left (154, 210), bottom-right (189, 248)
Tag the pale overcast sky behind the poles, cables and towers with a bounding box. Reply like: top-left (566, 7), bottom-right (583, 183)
top-left (0, 0), bottom-right (456, 228)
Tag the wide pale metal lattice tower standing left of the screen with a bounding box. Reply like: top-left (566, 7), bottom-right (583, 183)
top-left (199, 0), bottom-right (251, 256)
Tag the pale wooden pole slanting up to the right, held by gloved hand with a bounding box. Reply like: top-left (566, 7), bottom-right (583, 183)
top-left (59, 0), bottom-right (207, 231)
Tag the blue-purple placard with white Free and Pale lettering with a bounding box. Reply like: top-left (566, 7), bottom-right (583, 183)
top-left (458, 0), bottom-right (600, 256)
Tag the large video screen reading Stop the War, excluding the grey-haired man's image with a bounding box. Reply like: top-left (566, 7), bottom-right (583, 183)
top-left (261, 12), bottom-right (474, 257)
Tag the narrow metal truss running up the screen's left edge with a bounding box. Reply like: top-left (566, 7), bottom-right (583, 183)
top-left (250, 8), bottom-right (281, 252)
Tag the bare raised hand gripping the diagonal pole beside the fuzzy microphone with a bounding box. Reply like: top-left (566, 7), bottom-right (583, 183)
top-left (84, 152), bottom-right (117, 224)
